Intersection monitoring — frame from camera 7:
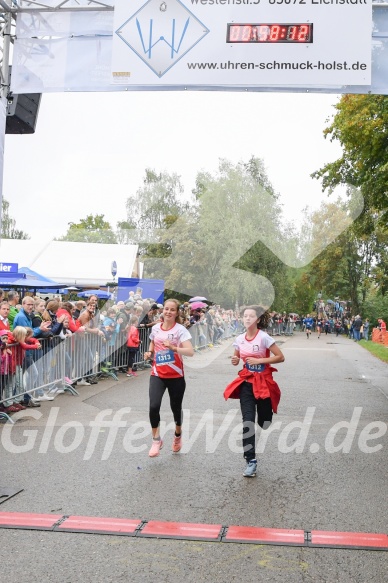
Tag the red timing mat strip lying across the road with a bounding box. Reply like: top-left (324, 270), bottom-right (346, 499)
top-left (0, 512), bottom-right (388, 551)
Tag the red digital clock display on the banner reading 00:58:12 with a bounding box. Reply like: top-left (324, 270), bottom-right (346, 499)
top-left (226, 23), bottom-right (313, 43)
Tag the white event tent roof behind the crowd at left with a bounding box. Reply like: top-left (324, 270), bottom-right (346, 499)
top-left (0, 239), bottom-right (142, 287)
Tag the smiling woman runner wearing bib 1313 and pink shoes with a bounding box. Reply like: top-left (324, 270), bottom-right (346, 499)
top-left (144, 299), bottom-right (194, 457)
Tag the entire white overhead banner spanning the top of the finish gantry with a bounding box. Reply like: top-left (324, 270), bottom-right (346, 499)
top-left (11, 0), bottom-right (388, 94)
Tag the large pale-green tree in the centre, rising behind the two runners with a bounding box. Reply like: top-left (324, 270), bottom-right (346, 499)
top-left (146, 158), bottom-right (292, 307)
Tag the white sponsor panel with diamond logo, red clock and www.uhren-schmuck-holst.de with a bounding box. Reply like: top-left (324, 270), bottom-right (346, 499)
top-left (111, 0), bottom-right (372, 87)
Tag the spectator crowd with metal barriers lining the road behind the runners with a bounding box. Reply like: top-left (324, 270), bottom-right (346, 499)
top-left (0, 289), bottom-right (386, 415)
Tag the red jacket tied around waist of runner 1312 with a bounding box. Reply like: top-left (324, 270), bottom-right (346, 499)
top-left (224, 366), bottom-right (281, 413)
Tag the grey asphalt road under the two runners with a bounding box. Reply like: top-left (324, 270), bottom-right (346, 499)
top-left (0, 333), bottom-right (388, 583)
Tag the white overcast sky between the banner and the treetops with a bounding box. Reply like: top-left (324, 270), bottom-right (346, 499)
top-left (3, 91), bottom-right (341, 237)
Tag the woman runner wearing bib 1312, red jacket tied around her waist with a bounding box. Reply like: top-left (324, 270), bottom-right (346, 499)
top-left (224, 306), bottom-right (284, 478)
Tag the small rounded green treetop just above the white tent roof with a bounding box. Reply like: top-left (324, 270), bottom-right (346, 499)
top-left (58, 215), bottom-right (117, 243)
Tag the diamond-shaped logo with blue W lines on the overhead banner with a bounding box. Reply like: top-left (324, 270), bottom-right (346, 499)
top-left (116, 0), bottom-right (210, 77)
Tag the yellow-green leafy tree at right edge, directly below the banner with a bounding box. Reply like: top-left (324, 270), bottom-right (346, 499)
top-left (313, 95), bottom-right (388, 305)
